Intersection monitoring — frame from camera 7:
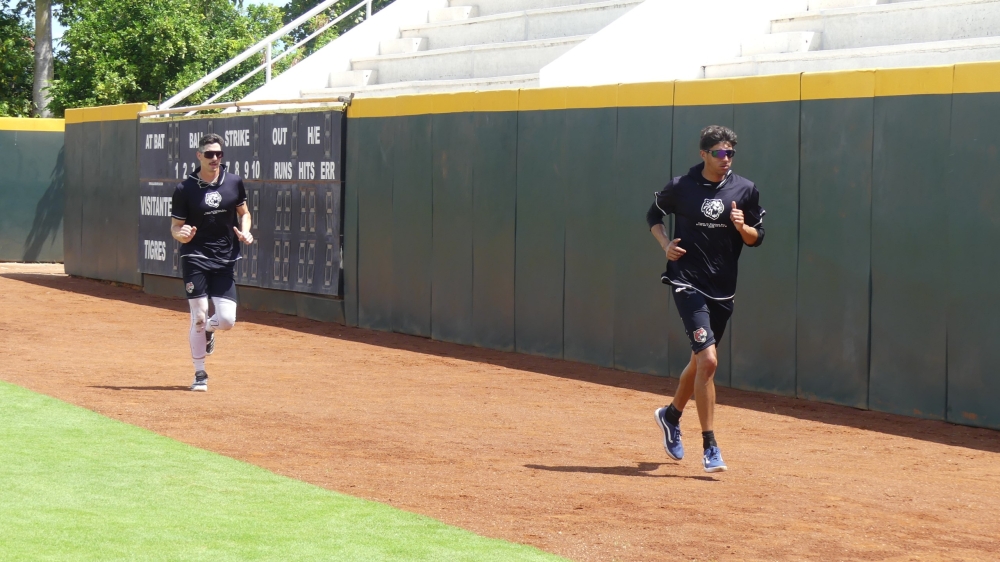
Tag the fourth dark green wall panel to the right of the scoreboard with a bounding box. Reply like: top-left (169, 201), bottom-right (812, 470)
top-left (472, 112), bottom-right (518, 351)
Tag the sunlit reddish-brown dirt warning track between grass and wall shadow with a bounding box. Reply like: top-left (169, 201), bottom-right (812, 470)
top-left (0, 264), bottom-right (1000, 561)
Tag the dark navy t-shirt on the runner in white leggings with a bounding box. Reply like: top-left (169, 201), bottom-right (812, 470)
top-left (171, 165), bottom-right (247, 269)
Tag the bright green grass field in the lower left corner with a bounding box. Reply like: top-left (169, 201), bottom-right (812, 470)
top-left (0, 382), bottom-right (561, 561)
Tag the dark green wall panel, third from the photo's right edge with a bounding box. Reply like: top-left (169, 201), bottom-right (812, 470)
top-left (796, 98), bottom-right (874, 408)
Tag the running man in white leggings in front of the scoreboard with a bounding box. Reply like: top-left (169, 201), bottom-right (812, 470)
top-left (170, 134), bottom-right (253, 391)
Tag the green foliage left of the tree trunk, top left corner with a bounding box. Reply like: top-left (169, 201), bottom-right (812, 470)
top-left (0, 4), bottom-right (35, 117)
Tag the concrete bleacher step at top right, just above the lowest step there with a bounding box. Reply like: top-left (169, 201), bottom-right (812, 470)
top-left (771, 0), bottom-right (1000, 50)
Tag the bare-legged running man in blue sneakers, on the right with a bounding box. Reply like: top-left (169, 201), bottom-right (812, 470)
top-left (646, 125), bottom-right (764, 472)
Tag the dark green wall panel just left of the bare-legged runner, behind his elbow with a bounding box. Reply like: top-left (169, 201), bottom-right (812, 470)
top-left (611, 107), bottom-right (672, 375)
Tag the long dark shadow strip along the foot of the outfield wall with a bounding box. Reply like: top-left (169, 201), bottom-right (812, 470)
top-left (7, 273), bottom-right (1000, 456)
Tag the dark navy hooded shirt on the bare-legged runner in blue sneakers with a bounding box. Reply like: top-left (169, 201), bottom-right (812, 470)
top-left (646, 163), bottom-right (765, 300)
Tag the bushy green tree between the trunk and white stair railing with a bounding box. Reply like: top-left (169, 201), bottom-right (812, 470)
top-left (51, 0), bottom-right (283, 115)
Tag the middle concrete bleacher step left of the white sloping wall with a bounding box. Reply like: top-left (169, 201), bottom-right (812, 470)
top-left (351, 35), bottom-right (590, 84)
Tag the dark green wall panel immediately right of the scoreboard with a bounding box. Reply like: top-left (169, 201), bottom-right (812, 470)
top-left (349, 118), bottom-right (395, 330)
